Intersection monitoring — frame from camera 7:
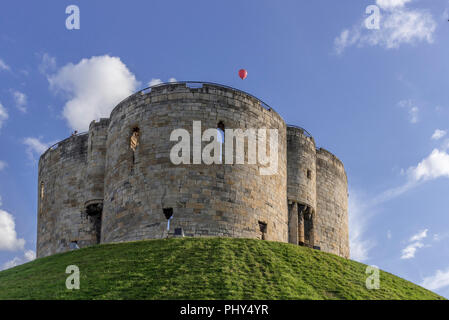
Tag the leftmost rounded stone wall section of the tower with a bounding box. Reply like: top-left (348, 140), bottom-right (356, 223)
top-left (36, 134), bottom-right (96, 258)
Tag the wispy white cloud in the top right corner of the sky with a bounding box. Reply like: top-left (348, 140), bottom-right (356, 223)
top-left (334, 0), bottom-right (436, 54)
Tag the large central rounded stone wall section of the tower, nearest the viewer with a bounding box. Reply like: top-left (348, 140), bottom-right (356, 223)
top-left (101, 84), bottom-right (288, 242)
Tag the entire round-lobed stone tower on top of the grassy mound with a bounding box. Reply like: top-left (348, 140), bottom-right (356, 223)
top-left (37, 82), bottom-right (349, 257)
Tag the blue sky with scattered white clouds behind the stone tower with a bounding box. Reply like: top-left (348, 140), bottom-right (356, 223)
top-left (0, 0), bottom-right (449, 297)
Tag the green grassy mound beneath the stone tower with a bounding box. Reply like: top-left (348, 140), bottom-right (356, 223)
top-left (0, 238), bottom-right (443, 299)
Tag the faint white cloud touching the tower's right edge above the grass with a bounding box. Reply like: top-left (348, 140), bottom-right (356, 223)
top-left (348, 190), bottom-right (376, 262)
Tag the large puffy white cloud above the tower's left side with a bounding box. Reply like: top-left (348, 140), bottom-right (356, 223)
top-left (48, 55), bottom-right (140, 131)
